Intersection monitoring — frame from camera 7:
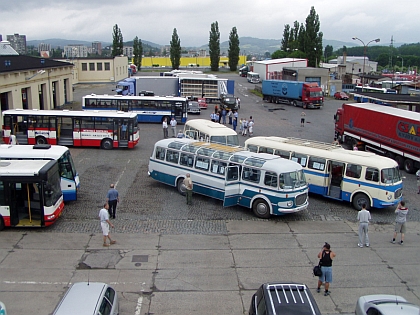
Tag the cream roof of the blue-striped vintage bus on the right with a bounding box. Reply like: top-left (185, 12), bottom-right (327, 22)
top-left (245, 136), bottom-right (398, 168)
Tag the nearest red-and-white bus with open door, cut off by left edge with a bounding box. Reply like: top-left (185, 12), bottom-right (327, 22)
top-left (0, 160), bottom-right (64, 230)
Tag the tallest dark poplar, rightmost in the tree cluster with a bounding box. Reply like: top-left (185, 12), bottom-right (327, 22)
top-left (304, 7), bottom-right (323, 67)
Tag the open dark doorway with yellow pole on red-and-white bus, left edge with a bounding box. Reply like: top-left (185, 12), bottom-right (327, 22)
top-left (5, 182), bottom-right (43, 226)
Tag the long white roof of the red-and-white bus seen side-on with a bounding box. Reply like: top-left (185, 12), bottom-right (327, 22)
top-left (2, 109), bottom-right (137, 119)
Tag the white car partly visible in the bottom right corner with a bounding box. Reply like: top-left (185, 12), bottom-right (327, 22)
top-left (355, 294), bottom-right (420, 315)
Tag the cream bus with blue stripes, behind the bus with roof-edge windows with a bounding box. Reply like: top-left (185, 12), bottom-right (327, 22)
top-left (245, 137), bottom-right (403, 210)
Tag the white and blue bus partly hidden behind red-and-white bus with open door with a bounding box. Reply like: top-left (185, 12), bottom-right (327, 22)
top-left (0, 144), bottom-right (80, 201)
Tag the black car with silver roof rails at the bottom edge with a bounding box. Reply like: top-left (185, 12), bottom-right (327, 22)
top-left (249, 282), bottom-right (321, 315)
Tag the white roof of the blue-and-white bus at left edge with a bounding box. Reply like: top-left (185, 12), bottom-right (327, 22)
top-left (0, 144), bottom-right (69, 160)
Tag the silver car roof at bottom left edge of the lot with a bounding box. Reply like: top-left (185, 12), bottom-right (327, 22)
top-left (53, 282), bottom-right (119, 315)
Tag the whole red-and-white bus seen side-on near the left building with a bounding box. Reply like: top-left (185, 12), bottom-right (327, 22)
top-left (3, 109), bottom-right (140, 150)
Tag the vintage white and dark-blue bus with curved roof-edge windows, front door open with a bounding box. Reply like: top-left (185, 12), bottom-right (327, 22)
top-left (149, 139), bottom-right (308, 218)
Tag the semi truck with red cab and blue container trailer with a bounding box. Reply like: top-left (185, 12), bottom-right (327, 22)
top-left (262, 80), bottom-right (324, 108)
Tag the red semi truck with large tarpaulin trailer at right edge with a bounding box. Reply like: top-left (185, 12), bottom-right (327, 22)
top-left (334, 103), bottom-right (420, 173)
